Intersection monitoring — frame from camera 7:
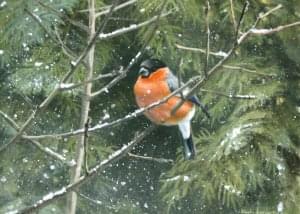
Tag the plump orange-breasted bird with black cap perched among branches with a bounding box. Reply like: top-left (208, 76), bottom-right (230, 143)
top-left (134, 58), bottom-right (210, 160)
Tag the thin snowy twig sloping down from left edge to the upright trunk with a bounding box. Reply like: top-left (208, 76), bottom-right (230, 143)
top-left (0, 111), bottom-right (75, 167)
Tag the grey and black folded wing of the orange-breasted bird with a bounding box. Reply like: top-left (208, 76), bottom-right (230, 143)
top-left (167, 71), bottom-right (211, 118)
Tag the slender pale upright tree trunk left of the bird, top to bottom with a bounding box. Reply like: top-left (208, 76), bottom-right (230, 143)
top-left (66, 0), bottom-right (96, 214)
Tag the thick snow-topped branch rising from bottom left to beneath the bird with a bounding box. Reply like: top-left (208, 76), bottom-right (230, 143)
top-left (9, 125), bottom-right (155, 214)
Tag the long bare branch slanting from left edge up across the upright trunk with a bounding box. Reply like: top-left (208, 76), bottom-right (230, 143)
top-left (0, 0), bottom-right (119, 153)
